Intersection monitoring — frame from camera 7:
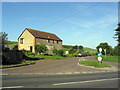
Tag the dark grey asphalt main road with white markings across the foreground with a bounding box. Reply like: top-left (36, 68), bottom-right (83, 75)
top-left (2, 71), bottom-right (118, 88)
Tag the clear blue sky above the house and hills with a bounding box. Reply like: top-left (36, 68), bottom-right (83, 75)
top-left (2, 2), bottom-right (118, 49)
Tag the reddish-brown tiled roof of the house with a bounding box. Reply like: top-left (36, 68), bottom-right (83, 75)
top-left (26, 28), bottom-right (62, 41)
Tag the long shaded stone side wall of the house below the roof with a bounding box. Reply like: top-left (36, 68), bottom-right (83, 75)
top-left (36, 38), bottom-right (62, 54)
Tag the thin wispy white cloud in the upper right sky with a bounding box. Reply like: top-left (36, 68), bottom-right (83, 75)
top-left (67, 15), bottom-right (118, 30)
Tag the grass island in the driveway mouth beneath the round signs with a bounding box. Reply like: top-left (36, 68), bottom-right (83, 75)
top-left (80, 60), bottom-right (110, 68)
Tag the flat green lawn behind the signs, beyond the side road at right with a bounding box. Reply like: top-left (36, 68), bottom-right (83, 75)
top-left (95, 55), bottom-right (120, 62)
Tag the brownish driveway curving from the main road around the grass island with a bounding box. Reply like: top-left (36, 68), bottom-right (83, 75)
top-left (2, 56), bottom-right (118, 74)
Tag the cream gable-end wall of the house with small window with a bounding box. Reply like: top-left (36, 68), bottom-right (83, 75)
top-left (18, 30), bottom-right (35, 53)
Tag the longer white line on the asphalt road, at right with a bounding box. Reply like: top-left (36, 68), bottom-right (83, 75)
top-left (53, 78), bottom-right (120, 85)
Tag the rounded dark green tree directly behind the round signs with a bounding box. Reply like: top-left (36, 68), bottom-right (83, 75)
top-left (96, 42), bottom-right (112, 54)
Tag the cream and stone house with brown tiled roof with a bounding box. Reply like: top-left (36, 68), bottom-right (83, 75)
top-left (18, 28), bottom-right (62, 54)
